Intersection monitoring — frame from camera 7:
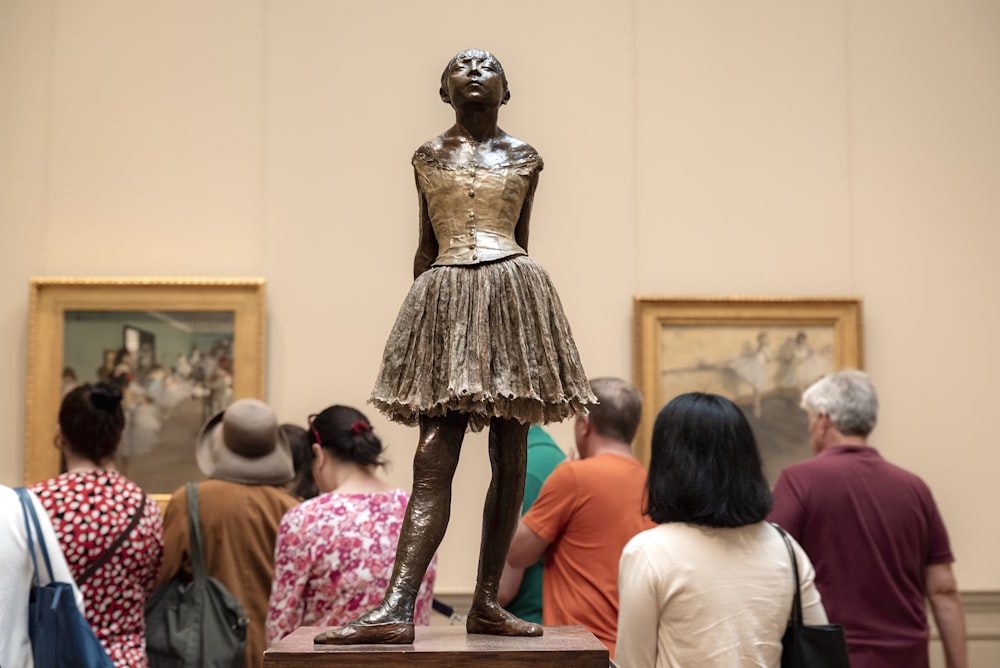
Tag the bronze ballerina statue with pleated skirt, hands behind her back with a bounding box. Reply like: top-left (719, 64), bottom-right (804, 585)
top-left (315, 50), bottom-right (596, 644)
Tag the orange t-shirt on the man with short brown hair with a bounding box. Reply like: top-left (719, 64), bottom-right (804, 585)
top-left (522, 453), bottom-right (655, 657)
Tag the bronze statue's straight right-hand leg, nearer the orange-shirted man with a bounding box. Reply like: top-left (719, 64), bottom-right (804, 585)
top-left (465, 418), bottom-right (542, 636)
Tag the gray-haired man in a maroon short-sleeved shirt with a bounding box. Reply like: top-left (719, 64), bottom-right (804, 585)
top-left (768, 370), bottom-right (967, 668)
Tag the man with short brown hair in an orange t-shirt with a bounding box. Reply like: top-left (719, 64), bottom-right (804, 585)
top-left (507, 378), bottom-right (654, 657)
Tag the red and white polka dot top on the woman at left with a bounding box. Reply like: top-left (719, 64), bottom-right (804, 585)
top-left (31, 470), bottom-right (163, 668)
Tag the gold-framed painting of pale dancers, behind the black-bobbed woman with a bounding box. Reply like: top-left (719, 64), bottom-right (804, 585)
top-left (633, 296), bottom-right (863, 484)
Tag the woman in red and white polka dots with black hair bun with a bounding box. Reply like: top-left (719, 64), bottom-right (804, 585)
top-left (31, 383), bottom-right (163, 668)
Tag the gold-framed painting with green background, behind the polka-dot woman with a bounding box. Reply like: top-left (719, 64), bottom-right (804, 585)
top-left (24, 277), bottom-right (266, 503)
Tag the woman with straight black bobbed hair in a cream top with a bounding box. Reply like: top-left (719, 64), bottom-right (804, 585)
top-left (615, 392), bottom-right (827, 668)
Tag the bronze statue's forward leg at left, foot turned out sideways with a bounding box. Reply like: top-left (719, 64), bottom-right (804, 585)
top-left (315, 413), bottom-right (468, 645)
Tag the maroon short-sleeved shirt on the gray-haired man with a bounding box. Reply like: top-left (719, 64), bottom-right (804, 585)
top-left (768, 445), bottom-right (954, 668)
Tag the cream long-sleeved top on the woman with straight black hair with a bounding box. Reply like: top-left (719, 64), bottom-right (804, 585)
top-left (615, 522), bottom-right (827, 668)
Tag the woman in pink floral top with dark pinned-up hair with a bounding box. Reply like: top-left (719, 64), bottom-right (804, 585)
top-left (266, 406), bottom-right (435, 646)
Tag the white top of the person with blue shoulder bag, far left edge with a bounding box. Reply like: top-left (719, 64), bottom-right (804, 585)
top-left (0, 485), bottom-right (83, 668)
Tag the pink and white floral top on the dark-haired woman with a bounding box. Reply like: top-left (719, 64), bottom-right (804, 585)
top-left (266, 489), bottom-right (436, 646)
